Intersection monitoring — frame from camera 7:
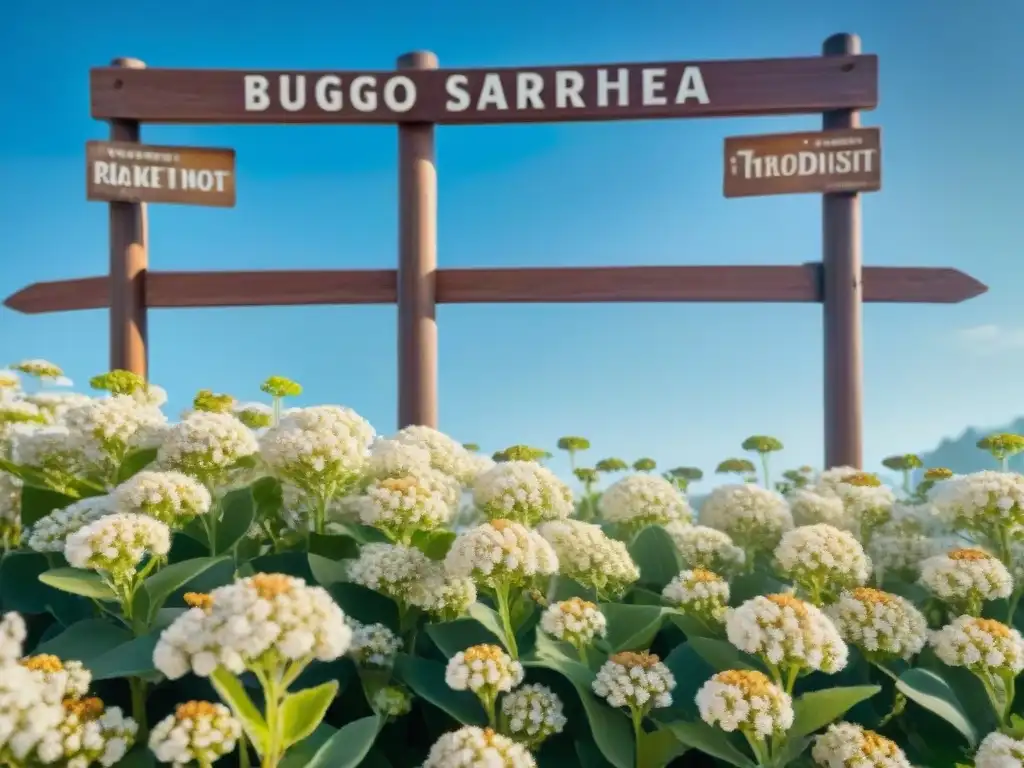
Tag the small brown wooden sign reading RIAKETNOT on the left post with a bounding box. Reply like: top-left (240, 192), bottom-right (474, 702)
top-left (85, 141), bottom-right (234, 208)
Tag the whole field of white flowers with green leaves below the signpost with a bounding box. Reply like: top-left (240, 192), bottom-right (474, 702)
top-left (0, 360), bottom-right (1024, 768)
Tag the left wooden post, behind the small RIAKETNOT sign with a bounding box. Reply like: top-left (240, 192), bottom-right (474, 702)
top-left (110, 58), bottom-right (148, 378)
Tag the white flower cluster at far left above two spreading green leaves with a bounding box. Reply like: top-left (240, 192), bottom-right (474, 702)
top-left (65, 513), bottom-right (171, 584)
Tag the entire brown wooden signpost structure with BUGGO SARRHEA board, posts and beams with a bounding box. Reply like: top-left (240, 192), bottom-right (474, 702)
top-left (5, 35), bottom-right (986, 467)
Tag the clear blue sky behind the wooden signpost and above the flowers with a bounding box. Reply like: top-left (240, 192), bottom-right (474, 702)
top-left (0, 0), bottom-right (1024, 489)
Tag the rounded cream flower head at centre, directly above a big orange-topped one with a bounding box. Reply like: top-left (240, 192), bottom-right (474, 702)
top-left (473, 461), bottom-right (574, 525)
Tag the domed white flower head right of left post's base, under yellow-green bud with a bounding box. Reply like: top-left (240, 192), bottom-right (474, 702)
top-left (156, 411), bottom-right (259, 493)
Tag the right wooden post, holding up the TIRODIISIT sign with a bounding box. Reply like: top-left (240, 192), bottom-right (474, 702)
top-left (821, 34), bottom-right (864, 469)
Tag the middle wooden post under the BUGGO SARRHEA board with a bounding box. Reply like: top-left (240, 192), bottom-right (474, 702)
top-left (398, 51), bottom-right (437, 428)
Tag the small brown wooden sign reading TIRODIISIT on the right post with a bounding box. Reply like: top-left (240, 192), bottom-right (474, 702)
top-left (725, 128), bottom-right (882, 198)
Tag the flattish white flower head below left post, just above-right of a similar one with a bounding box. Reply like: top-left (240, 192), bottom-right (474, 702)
top-left (111, 470), bottom-right (213, 528)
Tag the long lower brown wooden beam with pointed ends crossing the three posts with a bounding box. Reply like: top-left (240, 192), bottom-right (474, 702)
top-left (4, 263), bottom-right (988, 314)
